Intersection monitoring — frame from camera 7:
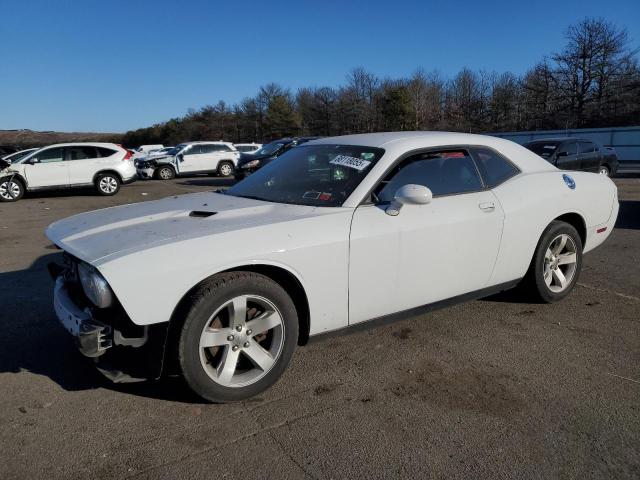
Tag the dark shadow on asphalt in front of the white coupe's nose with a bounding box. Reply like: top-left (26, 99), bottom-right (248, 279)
top-left (0, 251), bottom-right (208, 404)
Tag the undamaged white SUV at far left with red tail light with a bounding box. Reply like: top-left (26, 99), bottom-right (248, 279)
top-left (0, 143), bottom-right (136, 202)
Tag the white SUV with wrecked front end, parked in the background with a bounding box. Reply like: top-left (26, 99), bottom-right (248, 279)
top-left (137, 142), bottom-right (240, 180)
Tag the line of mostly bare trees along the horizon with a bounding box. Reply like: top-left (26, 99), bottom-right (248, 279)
top-left (123, 18), bottom-right (640, 146)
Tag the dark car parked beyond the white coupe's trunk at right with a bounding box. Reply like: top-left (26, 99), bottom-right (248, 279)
top-left (524, 137), bottom-right (618, 175)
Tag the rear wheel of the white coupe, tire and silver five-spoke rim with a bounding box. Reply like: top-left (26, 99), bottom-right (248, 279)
top-left (525, 221), bottom-right (583, 303)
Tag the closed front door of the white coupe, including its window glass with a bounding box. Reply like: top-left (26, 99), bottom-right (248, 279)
top-left (349, 150), bottom-right (504, 323)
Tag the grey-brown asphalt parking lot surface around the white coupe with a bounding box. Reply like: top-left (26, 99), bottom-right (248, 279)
top-left (0, 177), bottom-right (640, 479)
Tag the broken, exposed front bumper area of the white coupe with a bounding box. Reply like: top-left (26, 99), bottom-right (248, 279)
top-left (49, 260), bottom-right (168, 383)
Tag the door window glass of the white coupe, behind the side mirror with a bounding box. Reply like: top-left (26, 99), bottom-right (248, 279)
top-left (376, 150), bottom-right (482, 202)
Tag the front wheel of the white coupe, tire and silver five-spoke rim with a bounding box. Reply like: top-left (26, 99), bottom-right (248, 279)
top-left (178, 272), bottom-right (298, 403)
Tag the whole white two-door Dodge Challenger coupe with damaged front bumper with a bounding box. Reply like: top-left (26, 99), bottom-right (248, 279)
top-left (47, 132), bottom-right (618, 402)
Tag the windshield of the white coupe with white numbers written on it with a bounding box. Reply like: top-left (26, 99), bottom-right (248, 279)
top-left (225, 145), bottom-right (384, 207)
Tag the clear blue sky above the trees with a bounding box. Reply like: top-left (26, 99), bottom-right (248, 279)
top-left (0, 0), bottom-right (640, 132)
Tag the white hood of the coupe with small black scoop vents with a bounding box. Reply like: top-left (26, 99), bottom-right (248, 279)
top-left (46, 192), bottom-right (341, 265)
